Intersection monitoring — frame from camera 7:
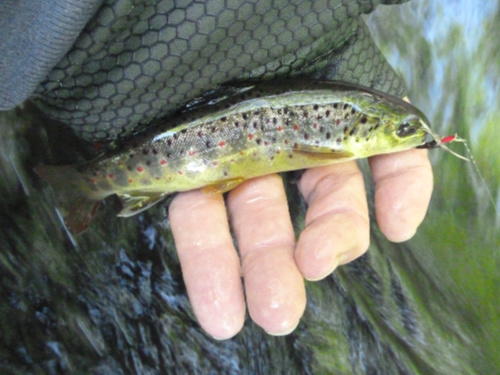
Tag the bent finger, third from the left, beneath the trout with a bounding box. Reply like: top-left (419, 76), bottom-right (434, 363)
top-left (295, 162), bottom-right (370, 280)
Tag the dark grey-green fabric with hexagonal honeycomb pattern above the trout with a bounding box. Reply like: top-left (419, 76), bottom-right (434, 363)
top-left (0, 0), bottom-right (410, 140)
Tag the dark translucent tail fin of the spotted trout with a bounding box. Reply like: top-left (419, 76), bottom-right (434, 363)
top-left (35, 165), bottom-right (100, 234)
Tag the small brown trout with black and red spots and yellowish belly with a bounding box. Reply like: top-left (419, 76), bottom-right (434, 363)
top-left (35, 79), bottom-right (439, 233)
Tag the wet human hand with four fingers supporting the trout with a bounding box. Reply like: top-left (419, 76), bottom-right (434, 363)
top-left (169, 150), bottom-right (433, 339)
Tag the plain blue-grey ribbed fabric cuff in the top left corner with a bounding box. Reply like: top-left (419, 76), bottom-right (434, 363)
top-left (0, 0), bottom-right (102, 110)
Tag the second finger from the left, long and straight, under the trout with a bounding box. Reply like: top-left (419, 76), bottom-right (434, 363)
top-left (228, 175), bottom-right (306, 335)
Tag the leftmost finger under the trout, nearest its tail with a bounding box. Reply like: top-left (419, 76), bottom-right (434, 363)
top-left (169, 190), bottom-right (245, 339)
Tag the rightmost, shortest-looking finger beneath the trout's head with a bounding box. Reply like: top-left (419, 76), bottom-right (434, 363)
top-left (370, 150), bottom-right (433, 242)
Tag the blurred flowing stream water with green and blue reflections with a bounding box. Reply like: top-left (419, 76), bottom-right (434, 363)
top-left (0, 0), bottom-right (500, 375)
